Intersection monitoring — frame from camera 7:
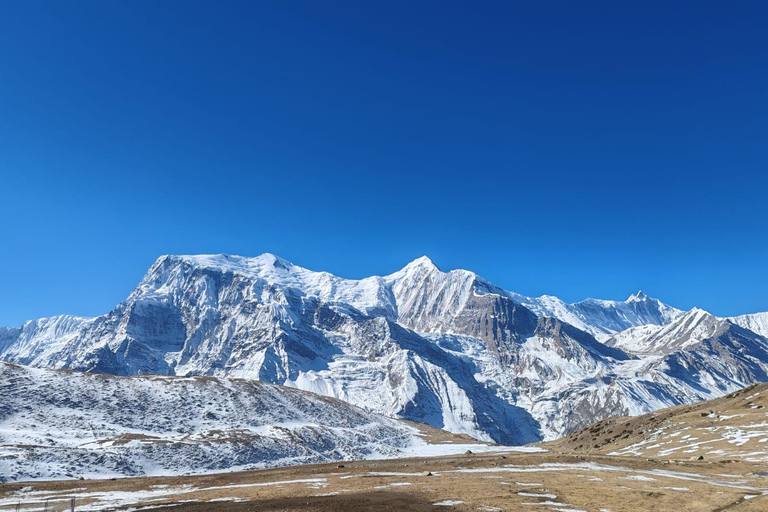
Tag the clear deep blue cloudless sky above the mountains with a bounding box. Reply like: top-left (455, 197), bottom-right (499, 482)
top-left (0, 0), bottom-right (768, 325)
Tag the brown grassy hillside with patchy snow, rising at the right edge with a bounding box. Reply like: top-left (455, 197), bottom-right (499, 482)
top-left (547, 378), bottom-right (768, 463)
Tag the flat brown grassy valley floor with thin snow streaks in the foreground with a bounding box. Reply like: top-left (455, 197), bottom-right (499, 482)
top-left (0, 451), bottom-right (768, 512)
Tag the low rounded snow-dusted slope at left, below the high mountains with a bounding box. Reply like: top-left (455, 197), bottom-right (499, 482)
top-left (0, 362), bottom-right (504, 481)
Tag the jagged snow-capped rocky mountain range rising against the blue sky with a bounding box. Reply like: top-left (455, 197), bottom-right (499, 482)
top-left (0, 254), bottom-right (768, 444)
